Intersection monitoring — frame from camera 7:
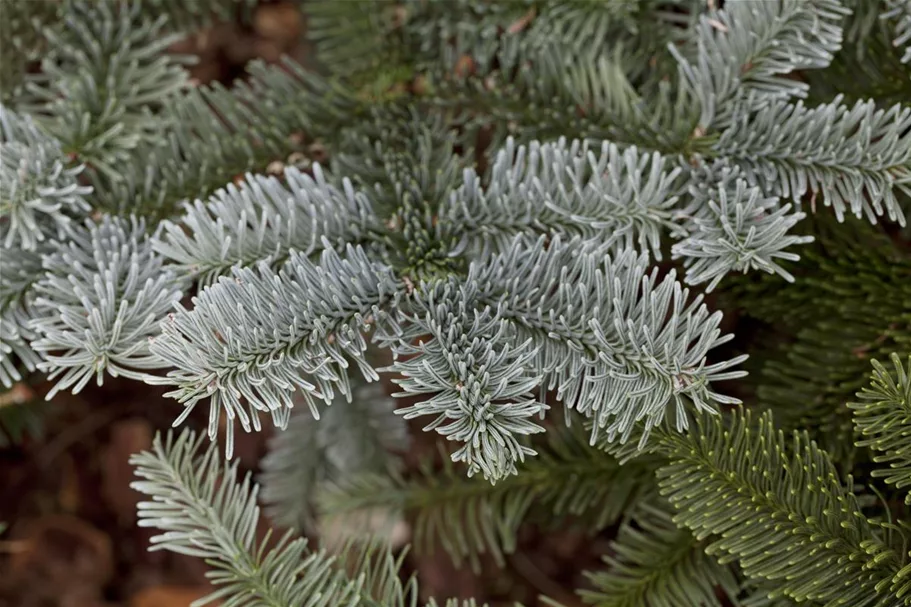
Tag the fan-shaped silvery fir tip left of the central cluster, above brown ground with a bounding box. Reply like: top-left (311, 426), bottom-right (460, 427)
top-left (29, 216), bottom-right (183, 400)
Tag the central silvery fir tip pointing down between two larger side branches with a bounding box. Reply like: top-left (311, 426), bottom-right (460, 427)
top-left (388, 279), bottom-right (547, 482)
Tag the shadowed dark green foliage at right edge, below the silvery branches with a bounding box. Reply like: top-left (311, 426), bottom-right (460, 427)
top-left (727, 218), bottom-right (911, 466)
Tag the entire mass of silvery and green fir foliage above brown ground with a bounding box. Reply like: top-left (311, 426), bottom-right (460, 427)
top-left (0, 0), bottom-right (911, 607)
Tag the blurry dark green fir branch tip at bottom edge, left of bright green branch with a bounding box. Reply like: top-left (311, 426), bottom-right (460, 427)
top-left (579, 503), bottom-right (740, 607)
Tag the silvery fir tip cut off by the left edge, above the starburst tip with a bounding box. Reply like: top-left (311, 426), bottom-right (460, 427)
top-left (0, 105), bottom-right (91, 251)
